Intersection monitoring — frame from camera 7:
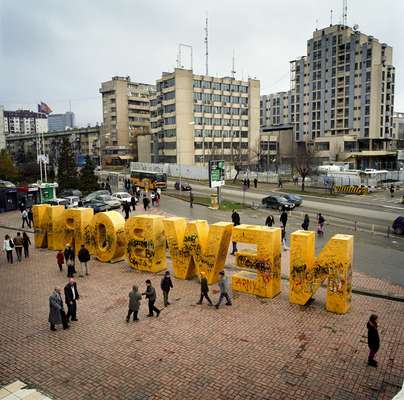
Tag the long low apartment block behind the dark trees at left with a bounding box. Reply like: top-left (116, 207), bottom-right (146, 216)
top-left (6, 126), bottom-right (101, 166)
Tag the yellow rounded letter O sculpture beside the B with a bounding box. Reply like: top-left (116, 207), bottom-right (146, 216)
top-left (91, 211), bottom-right (126, 262)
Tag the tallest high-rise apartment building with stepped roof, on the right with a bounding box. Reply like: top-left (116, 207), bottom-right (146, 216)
top-left (289, 25), bottom-right (395, 163)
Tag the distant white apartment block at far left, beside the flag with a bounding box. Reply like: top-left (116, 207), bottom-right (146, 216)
top-left (4, 110), bottom-right (48, 136)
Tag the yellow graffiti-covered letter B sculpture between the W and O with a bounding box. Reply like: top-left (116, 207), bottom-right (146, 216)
top-left (125, 215), bottom-right (166, 272)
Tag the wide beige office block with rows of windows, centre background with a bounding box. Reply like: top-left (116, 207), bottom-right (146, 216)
top-left (151, 68), bottom-right (260, 165)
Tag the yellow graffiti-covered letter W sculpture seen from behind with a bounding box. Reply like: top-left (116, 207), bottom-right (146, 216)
top-left (163, 217), bottom-right (233, 284)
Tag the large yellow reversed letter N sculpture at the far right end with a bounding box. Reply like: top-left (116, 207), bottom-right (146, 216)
top-left (289, 231), bottom-right (353, 314)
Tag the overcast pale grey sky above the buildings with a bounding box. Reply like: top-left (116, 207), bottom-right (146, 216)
top-left (0, 0), bottom-right (404, 126)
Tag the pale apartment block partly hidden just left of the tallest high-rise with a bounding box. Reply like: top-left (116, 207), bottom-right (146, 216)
top-left (260, 91), bottom-right (290, 128)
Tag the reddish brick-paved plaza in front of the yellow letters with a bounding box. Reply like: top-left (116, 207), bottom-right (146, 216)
top-left (0, 209), bottom-right (404, 400)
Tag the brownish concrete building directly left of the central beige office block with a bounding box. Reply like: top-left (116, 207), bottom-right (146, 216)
top-left (100, 76), bottom-right (155, 164)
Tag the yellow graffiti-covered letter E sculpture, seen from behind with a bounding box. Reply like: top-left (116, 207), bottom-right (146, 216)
top-left (232, 225), bottom-right (281, 298)
